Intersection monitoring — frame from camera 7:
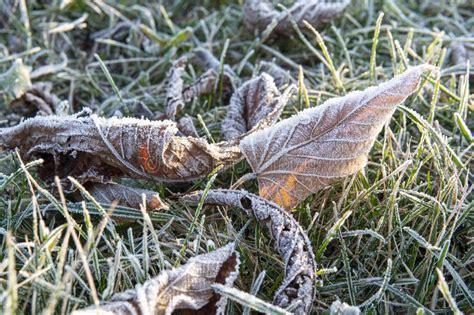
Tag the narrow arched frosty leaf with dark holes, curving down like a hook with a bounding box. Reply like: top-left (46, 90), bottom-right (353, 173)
top-left (182, 189), bottom-right (316, 314)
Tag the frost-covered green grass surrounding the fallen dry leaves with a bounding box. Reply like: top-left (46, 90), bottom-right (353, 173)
top-left (0, 0), bottom-right (474, 314)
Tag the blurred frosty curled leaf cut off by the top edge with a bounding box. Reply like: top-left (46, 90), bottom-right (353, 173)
top-left (244, 0), bottom-right (350, 35)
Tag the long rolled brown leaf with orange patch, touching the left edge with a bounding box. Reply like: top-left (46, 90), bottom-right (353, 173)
top-left (0, 115), bottom-right (241, 182)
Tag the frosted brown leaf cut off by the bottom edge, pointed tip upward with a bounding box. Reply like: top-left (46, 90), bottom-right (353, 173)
top-left (73, 243), bottom-right (240, 315)
